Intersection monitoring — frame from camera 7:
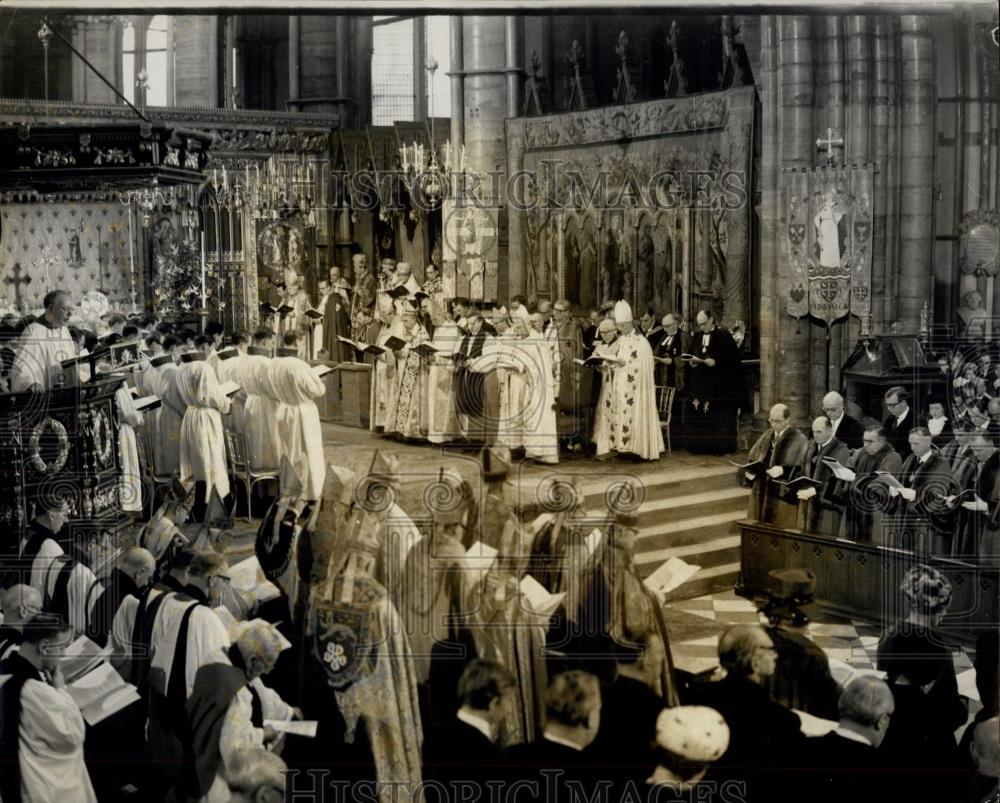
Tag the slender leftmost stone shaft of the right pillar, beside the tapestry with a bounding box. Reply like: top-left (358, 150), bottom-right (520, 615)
top-left (755, 14), bottom-right (785, 414)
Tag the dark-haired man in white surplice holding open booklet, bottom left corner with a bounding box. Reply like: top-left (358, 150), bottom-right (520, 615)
top-left (0, 614), bottom-right (97, 803)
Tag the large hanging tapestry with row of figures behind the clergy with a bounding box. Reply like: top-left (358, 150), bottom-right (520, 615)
top-left (506, 87), bottom-right (755, 325)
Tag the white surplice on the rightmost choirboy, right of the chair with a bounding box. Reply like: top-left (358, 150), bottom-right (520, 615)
top-left (270, 357), bottom-right (326, 499)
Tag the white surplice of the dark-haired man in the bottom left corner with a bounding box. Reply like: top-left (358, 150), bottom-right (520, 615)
top-left (18, 680), bottom-right (97, 803)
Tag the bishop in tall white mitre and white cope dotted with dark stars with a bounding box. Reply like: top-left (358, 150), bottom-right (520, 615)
top-left (598, 301), bottom-right (664, 460)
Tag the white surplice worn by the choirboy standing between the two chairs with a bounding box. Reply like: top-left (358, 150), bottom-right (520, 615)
top-left (177, 360), bottom-right (229, 504)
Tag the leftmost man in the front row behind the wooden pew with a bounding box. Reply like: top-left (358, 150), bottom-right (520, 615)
top-left (736, 404), bottom-right (806, 528)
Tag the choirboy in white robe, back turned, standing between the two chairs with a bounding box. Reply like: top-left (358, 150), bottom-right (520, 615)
top-left (177, 335), bottom-right (230, 521)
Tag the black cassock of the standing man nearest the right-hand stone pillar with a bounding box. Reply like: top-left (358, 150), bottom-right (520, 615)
top-left (685, 327), bottom-right (746, 454)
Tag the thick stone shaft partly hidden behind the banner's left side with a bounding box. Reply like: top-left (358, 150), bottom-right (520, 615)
top-left (762, 15), bottom-right (816, 421)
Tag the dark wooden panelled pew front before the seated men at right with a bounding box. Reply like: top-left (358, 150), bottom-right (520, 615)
top-left (740, 521), bottom-right (1000, 644)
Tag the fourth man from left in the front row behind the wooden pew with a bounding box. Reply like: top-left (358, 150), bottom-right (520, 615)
top-left (888, 427), bottom-right (958, 556)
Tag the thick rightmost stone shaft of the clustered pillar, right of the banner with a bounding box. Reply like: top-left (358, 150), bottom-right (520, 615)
top-left (896, 14), bottom-right (935, 334)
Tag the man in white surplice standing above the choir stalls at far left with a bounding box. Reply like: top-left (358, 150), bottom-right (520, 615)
top-left (10, 290), bottom-right (77, 393)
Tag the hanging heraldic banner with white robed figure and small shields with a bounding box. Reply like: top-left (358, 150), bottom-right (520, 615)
top-left (781, 164), bottom-right (874, 326)
